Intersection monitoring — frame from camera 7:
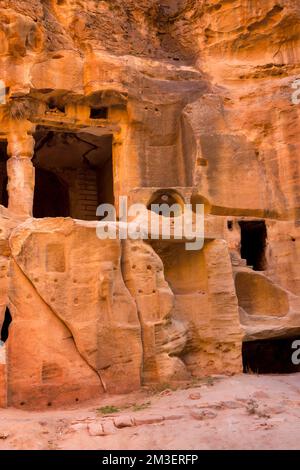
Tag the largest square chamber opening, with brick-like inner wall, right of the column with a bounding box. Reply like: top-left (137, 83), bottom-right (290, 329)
top-left (33, 126), bottom-right (114, 220)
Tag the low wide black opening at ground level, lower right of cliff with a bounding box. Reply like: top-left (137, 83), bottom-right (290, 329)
top-left (242, 336), bottom-right (300, 374)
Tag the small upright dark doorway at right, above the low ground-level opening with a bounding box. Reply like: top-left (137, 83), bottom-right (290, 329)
top-left (239, 220), bottom-right (267, 271)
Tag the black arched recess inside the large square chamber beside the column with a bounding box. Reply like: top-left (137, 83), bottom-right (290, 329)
top-left (33, 168), bottom-right (70, 219)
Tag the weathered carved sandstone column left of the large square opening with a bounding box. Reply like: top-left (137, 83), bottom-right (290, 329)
top-left (7, 123), bottom-right (35, 217)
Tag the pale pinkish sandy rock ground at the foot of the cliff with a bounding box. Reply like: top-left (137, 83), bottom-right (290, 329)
top-left (0, 374), bottom-right (300, 450)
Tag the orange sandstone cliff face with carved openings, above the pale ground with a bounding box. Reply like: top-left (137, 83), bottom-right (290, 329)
top-left (0, 0), bottom-right (300, 408)
